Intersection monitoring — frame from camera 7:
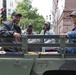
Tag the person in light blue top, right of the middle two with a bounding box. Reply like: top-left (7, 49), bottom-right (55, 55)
top-left (40, 21), bottom-right (55, 52)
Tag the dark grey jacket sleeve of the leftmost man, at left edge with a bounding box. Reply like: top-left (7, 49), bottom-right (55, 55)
top-left (0, 24), bottom-right (14, 36)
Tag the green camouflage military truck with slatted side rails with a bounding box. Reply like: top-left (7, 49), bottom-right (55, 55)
top-left (0, 35), bottom-right (76, 75)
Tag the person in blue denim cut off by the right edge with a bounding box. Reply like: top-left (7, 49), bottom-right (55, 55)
top-left (58, 11), bottom-right (76, 54)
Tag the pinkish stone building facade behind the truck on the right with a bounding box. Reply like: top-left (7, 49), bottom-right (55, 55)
top-left (53, 0), bottom-right (76, 35)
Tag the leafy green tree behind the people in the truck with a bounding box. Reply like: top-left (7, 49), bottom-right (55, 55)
top-left (16, 0), bottom-right (45, 33)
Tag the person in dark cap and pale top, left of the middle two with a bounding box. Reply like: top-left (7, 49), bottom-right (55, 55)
top-left (22, 23), bottom-right (40, 52)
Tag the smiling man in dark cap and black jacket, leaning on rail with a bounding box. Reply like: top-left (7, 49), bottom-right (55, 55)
top-left (0, 12), bottom-right (22, 52)
